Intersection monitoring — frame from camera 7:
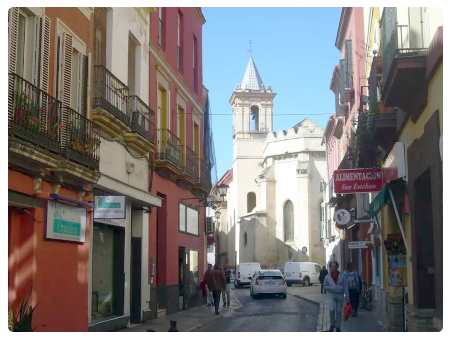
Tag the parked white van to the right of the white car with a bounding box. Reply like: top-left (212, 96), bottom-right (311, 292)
top-left (283, 262), bottom-right (322, 286)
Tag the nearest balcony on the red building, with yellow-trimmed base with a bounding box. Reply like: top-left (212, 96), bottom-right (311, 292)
top-left (155, 129), bottom-right (183, 180)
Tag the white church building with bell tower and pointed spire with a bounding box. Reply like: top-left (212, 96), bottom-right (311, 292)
top-left (216, 57), bottom-right (326, 267)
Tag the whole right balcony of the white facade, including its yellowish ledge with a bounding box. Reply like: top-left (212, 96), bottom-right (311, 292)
top-left (124, 95), bottom-right (155, 155)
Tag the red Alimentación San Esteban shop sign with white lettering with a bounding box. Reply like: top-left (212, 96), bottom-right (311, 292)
top-left (333, 168), bottom-right (383, 194)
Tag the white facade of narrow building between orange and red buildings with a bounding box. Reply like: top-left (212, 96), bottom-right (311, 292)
top-left (88, 7), bottom-right (161, 324)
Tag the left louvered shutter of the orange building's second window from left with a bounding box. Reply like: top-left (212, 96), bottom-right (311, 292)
top-left (61, 32), bottom-right (72, 148)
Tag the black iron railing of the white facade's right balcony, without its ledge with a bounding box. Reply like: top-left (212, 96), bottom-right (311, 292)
top-left (127, 95), bottom-right (155, 143)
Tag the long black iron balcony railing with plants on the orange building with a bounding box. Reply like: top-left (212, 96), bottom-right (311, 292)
top-left (8, 73), bottom-right (100, 170)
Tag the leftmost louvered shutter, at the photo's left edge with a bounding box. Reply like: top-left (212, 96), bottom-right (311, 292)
top-left (8, 7), bottom-right (19, 125)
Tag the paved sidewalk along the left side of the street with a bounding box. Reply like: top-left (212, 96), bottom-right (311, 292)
top-left (119, 294), bottom-right (241, 332)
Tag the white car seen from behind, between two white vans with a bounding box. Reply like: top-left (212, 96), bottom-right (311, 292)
top-left (250, 270), bottom-right (287, 298)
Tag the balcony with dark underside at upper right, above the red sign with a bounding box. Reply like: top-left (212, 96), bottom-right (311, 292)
top-left (381, 7), bottom-right (427, 120)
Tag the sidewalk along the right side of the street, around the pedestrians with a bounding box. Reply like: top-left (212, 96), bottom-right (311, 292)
top-left (288, 285), bottom-right (383, 332)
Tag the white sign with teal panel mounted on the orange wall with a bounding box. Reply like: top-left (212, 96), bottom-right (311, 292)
top-left (46, 201), bottom-right (86, 243)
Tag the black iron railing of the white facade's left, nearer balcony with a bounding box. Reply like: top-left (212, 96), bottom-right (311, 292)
top-left (93, 65), bottom-right (131, 126)
